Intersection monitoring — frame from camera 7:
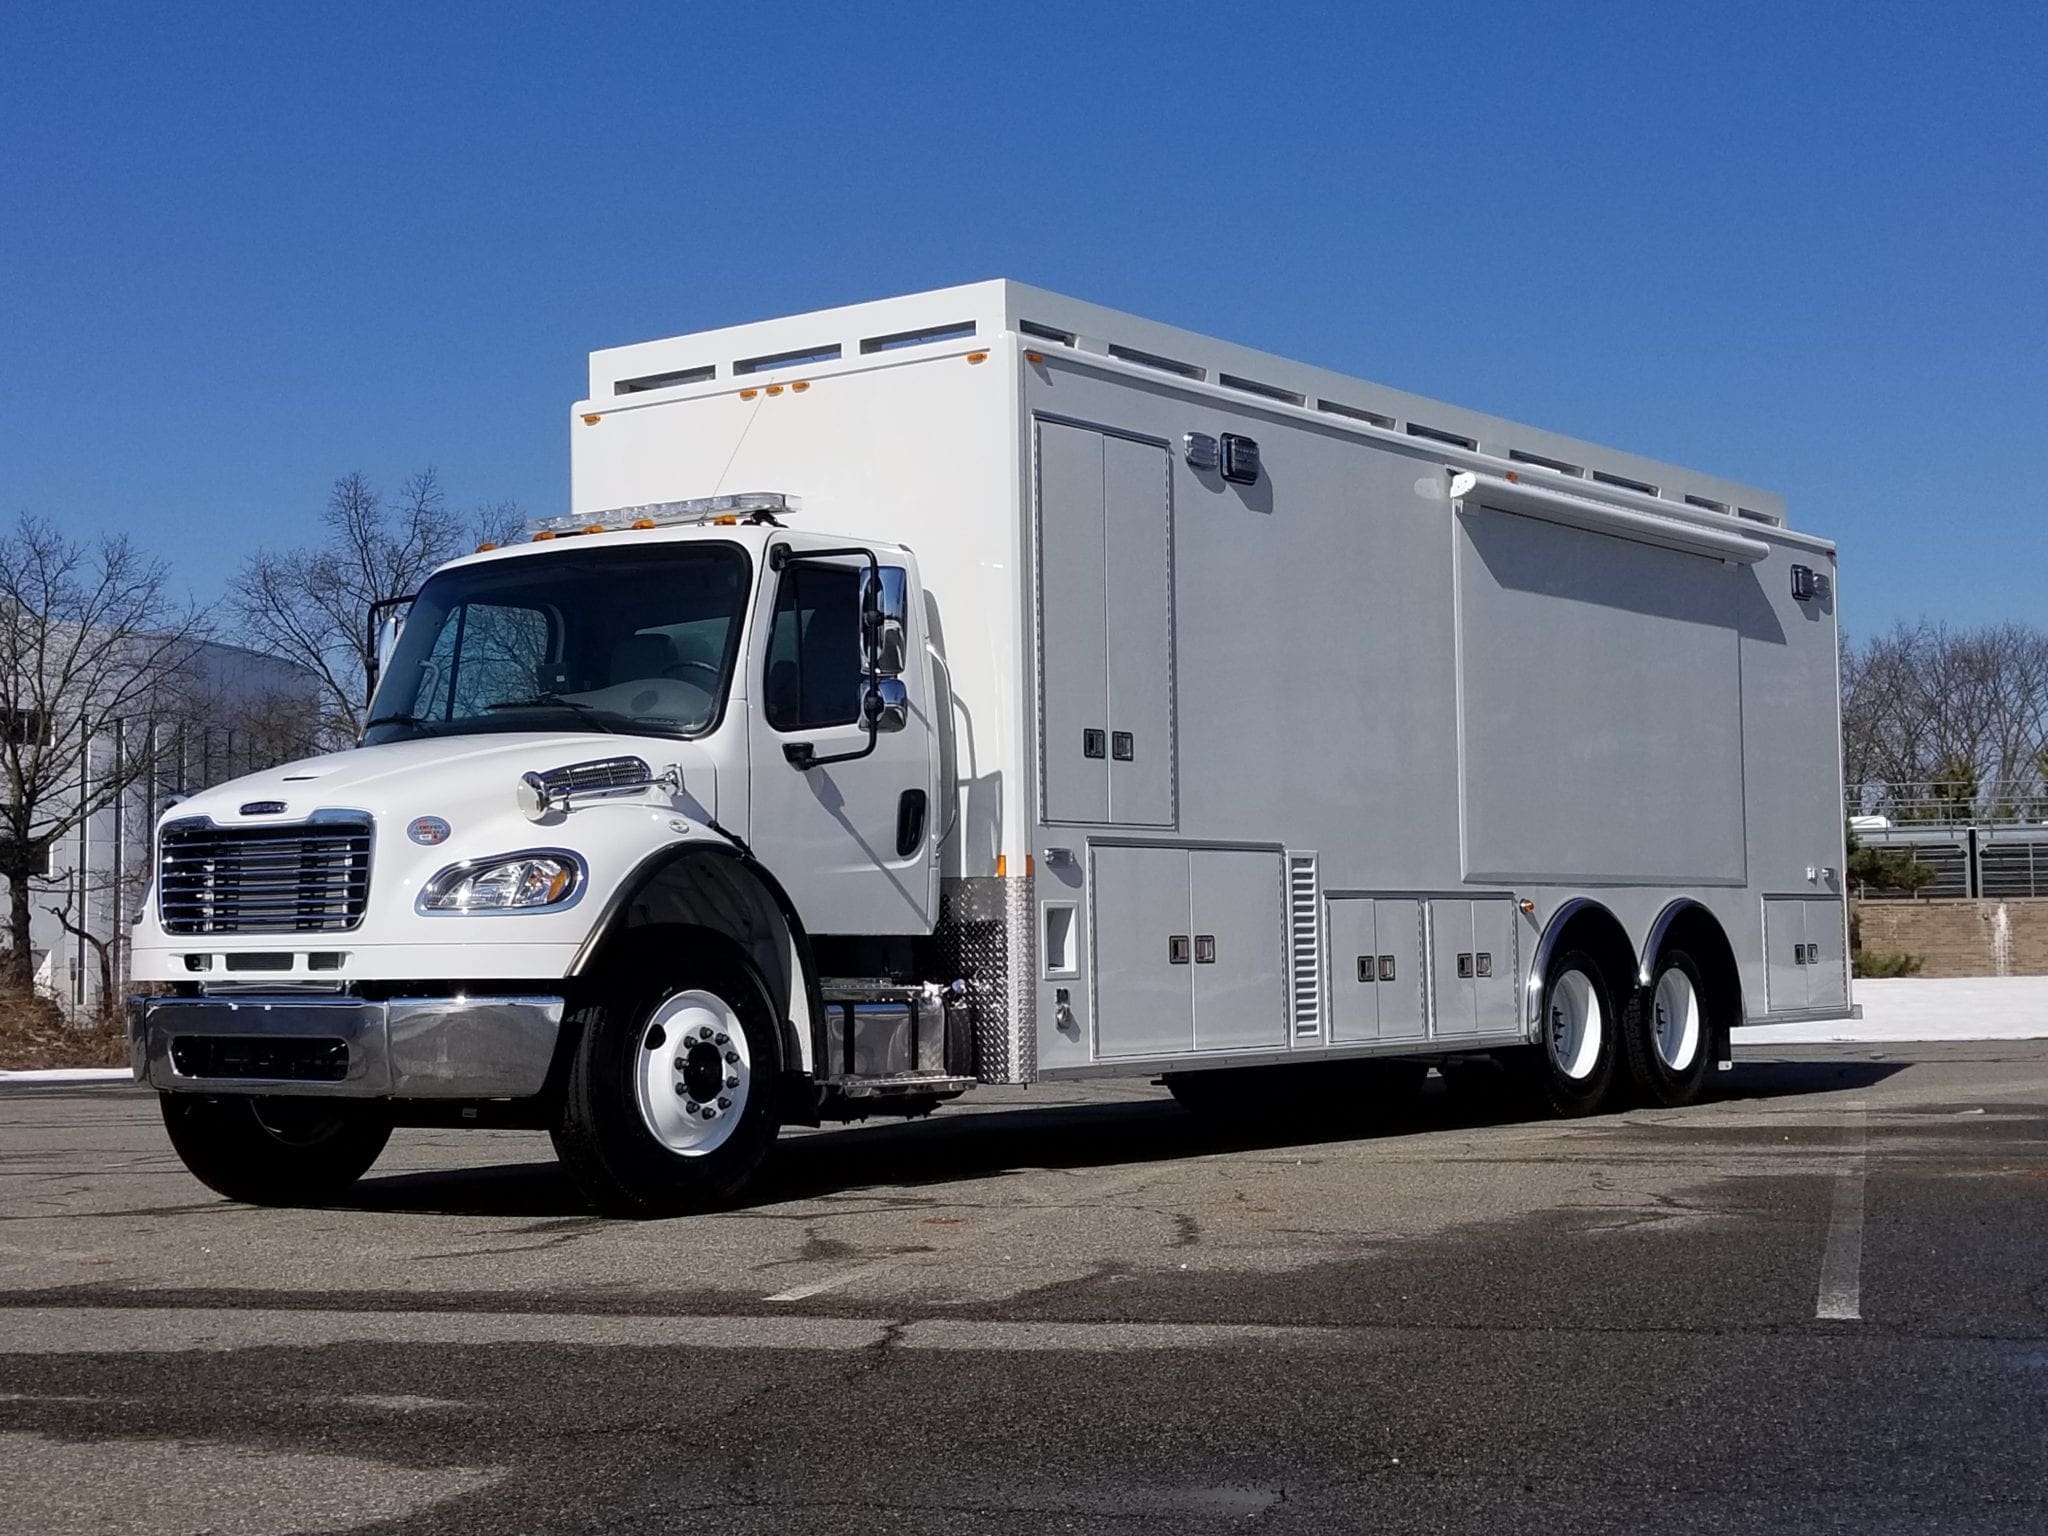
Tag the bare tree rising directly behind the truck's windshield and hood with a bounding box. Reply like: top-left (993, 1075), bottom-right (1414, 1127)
top-left (227, 469), bottom-right (524, 748)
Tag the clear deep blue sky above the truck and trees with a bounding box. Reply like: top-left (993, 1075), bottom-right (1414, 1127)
top-left (0, 0), bottom-right (2048, 633)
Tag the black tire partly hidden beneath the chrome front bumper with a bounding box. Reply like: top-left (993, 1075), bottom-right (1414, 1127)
top-left (158, 1094), bottom-right (391, 1206)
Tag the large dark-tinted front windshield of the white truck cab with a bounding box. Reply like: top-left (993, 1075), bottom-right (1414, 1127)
top-left (362, 543), bottom-right (748, 745)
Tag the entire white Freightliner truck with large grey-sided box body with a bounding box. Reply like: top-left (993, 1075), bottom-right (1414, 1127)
top-left (131, 281), bottom-right (1851, 1214)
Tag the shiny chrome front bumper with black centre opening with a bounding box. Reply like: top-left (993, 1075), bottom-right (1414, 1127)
top-left (129, 997), bottom-right (563, 1098)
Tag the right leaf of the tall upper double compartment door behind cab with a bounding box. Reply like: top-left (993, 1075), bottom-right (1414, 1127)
top-left (1102, 438), bottom-right (1174, 827)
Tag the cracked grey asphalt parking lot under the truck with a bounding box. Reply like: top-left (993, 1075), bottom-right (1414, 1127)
top-left (0, 1042), bottom-right (2048, 1536)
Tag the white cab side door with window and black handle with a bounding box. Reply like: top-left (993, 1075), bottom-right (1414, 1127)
top-left (745, 551), bottom-right (942, 934)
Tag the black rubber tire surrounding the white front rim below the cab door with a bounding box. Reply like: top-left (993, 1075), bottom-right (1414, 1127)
top-left (551, 944), bottom-right (782, 1219)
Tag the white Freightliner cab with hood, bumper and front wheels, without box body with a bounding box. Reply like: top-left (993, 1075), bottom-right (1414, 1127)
top-left (133, 494), bottom-right (973, 1212)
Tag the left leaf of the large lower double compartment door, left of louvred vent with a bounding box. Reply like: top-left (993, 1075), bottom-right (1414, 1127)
top-left (1090, 848), bottom-right (1208, 1057)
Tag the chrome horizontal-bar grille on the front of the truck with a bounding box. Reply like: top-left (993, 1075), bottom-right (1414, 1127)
top-left (156, 815), bottom-right (371, 934)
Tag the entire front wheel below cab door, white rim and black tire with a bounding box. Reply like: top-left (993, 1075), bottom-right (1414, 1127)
top-left (553, 954), bottom-right (782, 1217)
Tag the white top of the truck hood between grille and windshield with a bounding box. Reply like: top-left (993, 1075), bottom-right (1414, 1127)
top-left (166, 731), bottom-right (717, 823)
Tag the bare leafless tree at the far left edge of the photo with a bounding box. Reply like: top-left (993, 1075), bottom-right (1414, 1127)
top-left (0, 518), bottom-right (205, 989)
